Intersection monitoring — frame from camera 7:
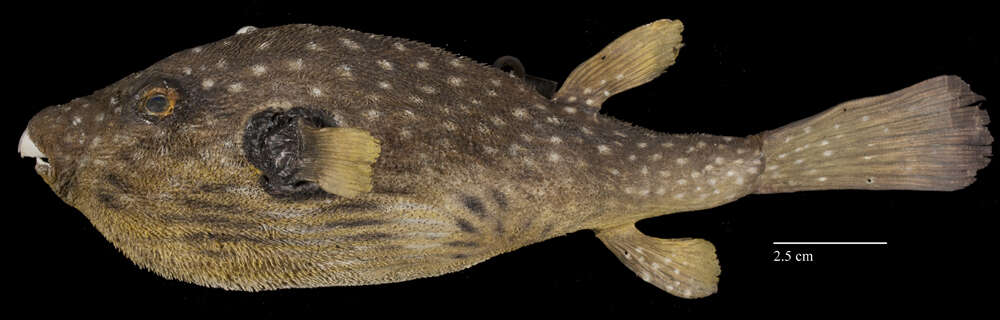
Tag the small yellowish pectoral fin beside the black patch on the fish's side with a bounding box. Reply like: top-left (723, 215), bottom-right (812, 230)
top-left (302, 126), bottom-right (381, 198)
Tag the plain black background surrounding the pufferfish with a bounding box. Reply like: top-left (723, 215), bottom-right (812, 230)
top-left (2, 2), bottom-right (1000, 318)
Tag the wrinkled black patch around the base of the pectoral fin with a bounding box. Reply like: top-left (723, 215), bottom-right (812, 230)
top-left (243, 107), bottom-right (337, 197)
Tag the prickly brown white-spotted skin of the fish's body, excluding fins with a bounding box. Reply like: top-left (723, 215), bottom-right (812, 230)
top-left (28, 25), bottom-right (763, 290)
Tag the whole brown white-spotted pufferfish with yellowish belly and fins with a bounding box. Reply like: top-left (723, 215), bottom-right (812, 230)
top-left (18, 20), bottom-right (993, 298)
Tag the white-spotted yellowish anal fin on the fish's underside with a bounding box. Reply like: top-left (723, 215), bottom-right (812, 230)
top-left (597, 224), bottom-right (721, 299)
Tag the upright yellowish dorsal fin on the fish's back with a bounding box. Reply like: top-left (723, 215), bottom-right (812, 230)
top-left (555, 19), bottom-right (684, 109)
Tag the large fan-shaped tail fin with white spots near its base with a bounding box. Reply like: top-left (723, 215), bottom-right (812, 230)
top-left (756, 76), bottom-right (993, 193)
